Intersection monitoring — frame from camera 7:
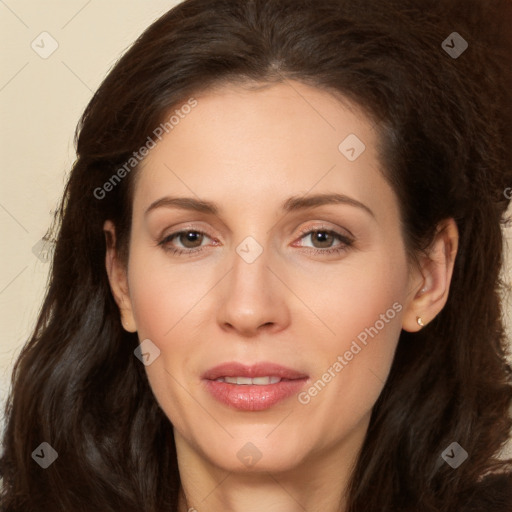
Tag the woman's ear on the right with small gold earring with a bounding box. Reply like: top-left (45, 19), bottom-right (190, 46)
top-left (402, 219), bottom-right (459, 332)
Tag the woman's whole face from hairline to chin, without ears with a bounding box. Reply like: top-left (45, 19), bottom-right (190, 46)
top-left (110, 82), bottom-right (418, 471)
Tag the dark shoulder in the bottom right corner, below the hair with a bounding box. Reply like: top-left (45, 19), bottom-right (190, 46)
top-left (460, 473), bottom-right (512, 512)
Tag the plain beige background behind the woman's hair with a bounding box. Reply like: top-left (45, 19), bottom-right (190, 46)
top-left (0, 0), bottom-right (512, 455)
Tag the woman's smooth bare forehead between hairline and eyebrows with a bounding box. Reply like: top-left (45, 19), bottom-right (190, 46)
top-left (134, 81), bottom-right (392, 221)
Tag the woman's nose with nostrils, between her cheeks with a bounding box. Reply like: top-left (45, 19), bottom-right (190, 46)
top-left (217, 243), bottom-right (290, 337)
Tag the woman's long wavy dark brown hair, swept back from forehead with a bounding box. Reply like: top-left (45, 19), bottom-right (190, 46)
top-left (0, 0), bottom-right (512, 512)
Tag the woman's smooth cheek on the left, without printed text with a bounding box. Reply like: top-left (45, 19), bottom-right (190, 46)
top-left (128, 248), bottom-right (218, 408)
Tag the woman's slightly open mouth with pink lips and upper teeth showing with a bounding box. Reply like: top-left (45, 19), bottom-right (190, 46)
top-left (202, 362), bottom-right (309, 411)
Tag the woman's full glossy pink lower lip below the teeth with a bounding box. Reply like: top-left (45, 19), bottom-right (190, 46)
top-left (204, 378), bottom-right (307, 411)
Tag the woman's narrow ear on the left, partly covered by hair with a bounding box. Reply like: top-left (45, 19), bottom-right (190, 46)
top-left (103, 220), bottom-right (137, 332)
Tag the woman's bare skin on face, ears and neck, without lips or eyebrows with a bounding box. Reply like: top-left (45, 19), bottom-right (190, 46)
top-left (105, 82), bottom-right (457, 512)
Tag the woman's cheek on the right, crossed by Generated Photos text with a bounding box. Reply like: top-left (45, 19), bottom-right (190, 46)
top-left (298, 246), bottom-right (407, 422)
